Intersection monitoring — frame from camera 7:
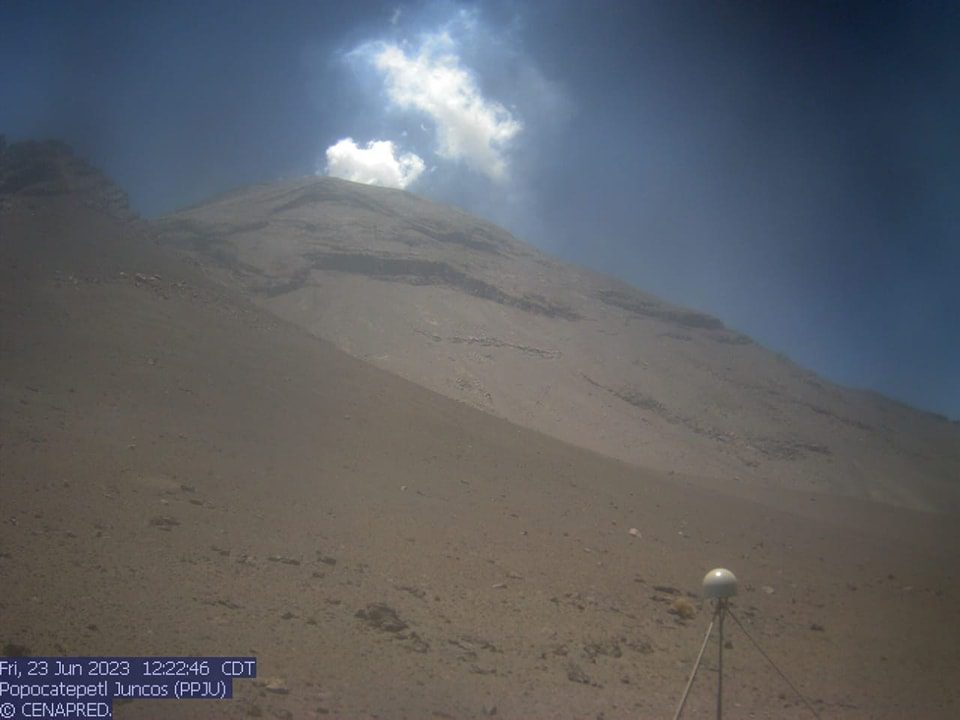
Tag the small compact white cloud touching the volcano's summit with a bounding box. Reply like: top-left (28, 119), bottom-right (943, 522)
top-left (326, 138), bottom-right (425, 188)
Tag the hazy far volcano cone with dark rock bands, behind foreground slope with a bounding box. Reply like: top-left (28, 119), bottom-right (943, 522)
top-left (157, 178), bottom-right (960, 513)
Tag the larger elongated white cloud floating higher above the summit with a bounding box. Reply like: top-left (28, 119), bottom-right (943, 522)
top-left (373, 33), bottom-right (523, 180)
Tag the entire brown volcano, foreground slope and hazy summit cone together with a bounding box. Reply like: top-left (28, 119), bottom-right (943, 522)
top-left (0, 143), bottom-right (960, 719)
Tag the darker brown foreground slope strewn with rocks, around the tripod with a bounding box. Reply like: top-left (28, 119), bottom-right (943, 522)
top-left (0, 144), bottom-right (960, 719)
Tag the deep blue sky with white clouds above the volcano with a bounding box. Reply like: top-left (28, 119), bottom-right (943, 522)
top-left (0, 0), bottom-right (960, 419)
